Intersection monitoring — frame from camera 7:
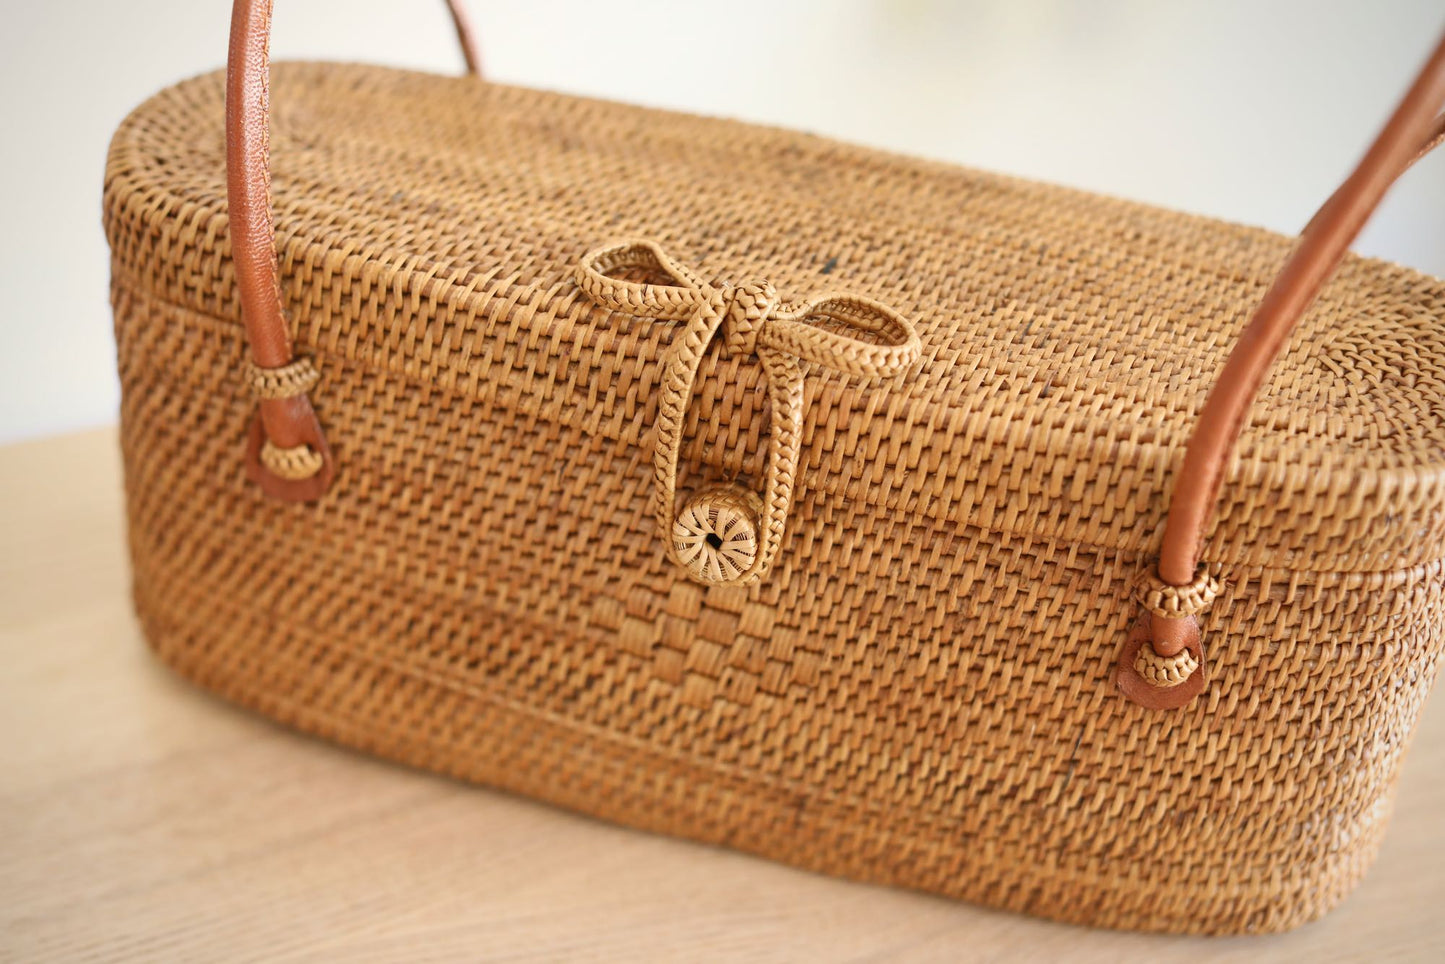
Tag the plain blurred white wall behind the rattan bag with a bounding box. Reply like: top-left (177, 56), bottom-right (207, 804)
top-left (0, 0), bottom-right (1445, 441)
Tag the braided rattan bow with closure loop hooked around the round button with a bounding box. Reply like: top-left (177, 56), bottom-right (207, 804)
top-left (577, 241), bottom-right (922, 584)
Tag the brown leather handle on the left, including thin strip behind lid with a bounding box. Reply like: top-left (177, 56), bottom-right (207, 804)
top-left (225, 0), bottom-right (481, 502)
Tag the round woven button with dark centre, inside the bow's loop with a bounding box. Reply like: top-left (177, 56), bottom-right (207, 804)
top-left (672, 484), bottom-right (763, 584)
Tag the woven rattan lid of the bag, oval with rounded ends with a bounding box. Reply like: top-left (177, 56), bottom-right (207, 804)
top-left (105, 64), bottom-right (1445, 571)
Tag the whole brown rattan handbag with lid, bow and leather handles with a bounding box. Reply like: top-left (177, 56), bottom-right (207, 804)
top-left (105, 0), bottom-right (1445, 932)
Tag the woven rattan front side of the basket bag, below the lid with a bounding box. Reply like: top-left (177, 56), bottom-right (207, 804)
top-left (114, 270), bottom-right (1445, 932)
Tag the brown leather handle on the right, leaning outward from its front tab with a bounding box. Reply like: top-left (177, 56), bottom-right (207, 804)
top-left (1118, 30), bottom-right (1445, 708)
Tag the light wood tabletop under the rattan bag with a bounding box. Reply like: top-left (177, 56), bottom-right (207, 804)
top-left (0, 431), bottom-right (1445, 963)
